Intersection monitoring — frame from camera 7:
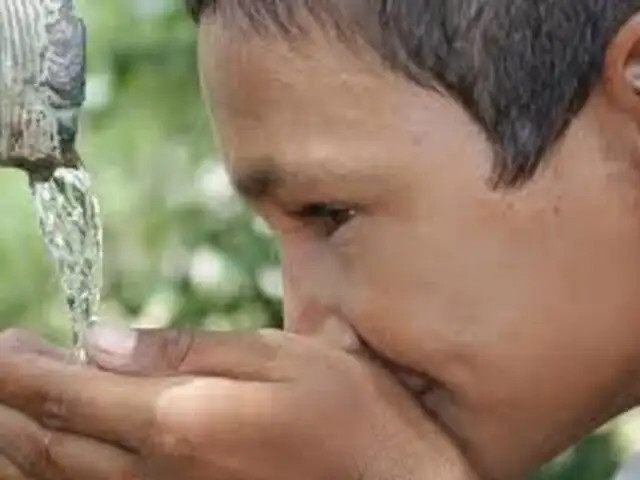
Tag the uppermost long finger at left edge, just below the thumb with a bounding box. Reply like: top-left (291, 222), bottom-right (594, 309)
top-left (0, 354), bottom-right (162, 451)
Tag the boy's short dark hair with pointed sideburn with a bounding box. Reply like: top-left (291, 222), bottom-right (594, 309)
top-left (186, 0), bottom-right (640, 185)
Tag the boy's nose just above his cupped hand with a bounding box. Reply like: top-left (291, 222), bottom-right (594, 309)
top-left (281, 238), bottom-right (359, 350)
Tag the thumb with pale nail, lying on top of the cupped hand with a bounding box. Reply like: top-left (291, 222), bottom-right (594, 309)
top-left (86, 323), bottom-right (293, 381)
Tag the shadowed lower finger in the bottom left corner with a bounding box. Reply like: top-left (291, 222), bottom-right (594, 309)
top-left (0, 407), bottom-right (139, 480)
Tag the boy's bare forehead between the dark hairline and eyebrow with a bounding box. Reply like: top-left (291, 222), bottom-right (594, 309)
top-left (199, 20), bottom-right (486, 191)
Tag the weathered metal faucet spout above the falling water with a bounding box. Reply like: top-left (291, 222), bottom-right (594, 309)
top-left (0, 0), bottom-right (86, 179)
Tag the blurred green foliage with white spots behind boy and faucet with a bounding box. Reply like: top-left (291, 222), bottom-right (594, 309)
top-left (0, 0), bottom-right (640, 480)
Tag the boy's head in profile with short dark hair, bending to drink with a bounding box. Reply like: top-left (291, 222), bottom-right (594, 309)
top-left (188, 0), bottom-right (640, 478)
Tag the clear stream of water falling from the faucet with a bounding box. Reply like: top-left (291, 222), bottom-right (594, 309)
top-left (30, 167), bottom-right (102, 363)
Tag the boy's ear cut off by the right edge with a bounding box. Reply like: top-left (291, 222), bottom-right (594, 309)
top-left (603, 14), bottom-right (640, 119)
